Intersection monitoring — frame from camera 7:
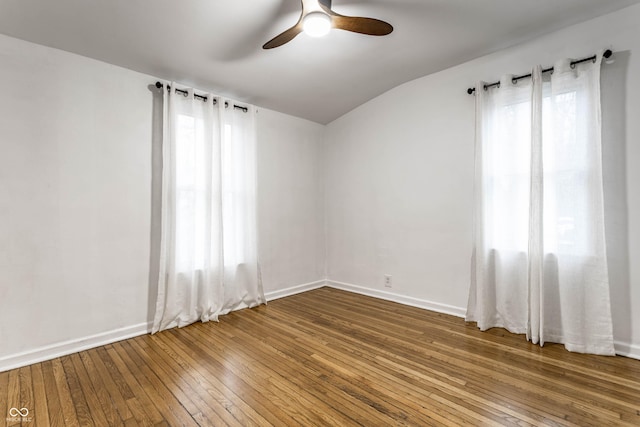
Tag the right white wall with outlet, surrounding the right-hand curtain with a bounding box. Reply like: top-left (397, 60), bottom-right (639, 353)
top-left (326, 6), bottom-right (640, 357)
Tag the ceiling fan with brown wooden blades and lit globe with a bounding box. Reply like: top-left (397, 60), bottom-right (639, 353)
top-left (262, 0), bottom-right (393, 49)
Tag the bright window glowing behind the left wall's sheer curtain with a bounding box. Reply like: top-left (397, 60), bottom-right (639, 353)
top-left (175, 108), bottom-right (255, 272)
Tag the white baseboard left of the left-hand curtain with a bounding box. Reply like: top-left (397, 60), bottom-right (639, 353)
top-left (0, 323), bottom-right (151, 372)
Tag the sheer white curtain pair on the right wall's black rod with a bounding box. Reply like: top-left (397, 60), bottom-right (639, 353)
top-left (466, 51), bottom-right (614, 355)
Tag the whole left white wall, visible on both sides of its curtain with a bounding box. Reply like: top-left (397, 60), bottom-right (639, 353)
top-left (0, 35), bottom-right (325, 371)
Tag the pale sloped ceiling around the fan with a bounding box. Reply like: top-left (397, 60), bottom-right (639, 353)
top-left (0, 0), bottom-right (640, 124)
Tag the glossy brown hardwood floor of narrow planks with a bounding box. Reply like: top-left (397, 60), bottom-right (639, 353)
top-left (0, 288), bottom-right (640, 427)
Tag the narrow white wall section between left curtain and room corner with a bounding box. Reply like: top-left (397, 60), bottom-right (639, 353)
top-left (258, 109), bottom-right (325, 299)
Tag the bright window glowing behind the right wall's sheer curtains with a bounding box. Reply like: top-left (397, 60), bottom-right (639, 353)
top-left (485, 84), bottom-right (593, 255)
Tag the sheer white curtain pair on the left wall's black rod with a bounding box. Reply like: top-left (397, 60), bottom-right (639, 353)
top-left (152, 83), bottom-right (266, 333)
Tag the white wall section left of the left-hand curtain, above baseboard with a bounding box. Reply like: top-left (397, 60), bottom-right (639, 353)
top-left (0, 36), bottom-right (152, 368)
